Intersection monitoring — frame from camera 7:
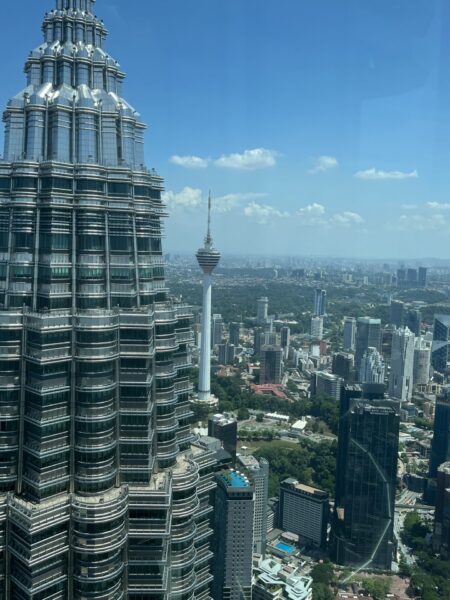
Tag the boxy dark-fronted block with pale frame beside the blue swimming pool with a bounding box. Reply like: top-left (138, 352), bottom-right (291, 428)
top-left (278, 479), bottom-right (330, 549)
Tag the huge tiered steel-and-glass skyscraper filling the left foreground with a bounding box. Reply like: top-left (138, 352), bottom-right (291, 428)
top-left (0, 0), bottom-right (213, 600)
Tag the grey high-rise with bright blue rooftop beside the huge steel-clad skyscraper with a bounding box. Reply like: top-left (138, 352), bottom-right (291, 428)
top-left (212, 470), bottom-right (255, 600)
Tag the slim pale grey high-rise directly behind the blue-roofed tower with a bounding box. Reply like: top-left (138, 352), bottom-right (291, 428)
top-left (239, 454), bottom-right (269, 555)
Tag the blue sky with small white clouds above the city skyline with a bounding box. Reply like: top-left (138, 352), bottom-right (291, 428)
top-left (0, 0), bottom-right (450, 258)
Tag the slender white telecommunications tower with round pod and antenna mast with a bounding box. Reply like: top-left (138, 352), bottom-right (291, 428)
top-left (197, 194), bottom-right (220, 406)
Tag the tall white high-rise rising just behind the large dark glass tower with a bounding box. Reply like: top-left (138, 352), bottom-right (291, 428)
top-left (389, 327), bottom-right (416, 402)
